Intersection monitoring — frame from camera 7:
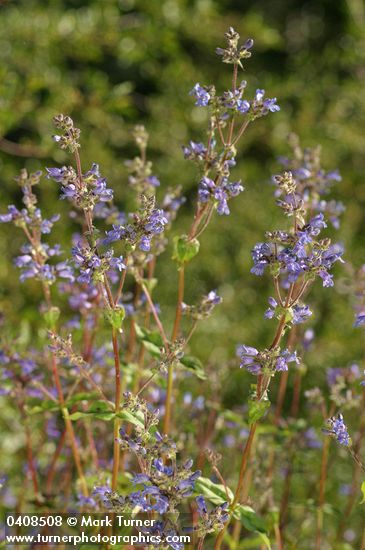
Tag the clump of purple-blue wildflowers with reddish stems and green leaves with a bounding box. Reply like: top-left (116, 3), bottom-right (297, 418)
top-left (0, 24), bottom-right (364, 550)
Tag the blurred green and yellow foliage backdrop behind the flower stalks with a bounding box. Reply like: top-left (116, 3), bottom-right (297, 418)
top-left (0, 0), bottom-right (365, 548)
